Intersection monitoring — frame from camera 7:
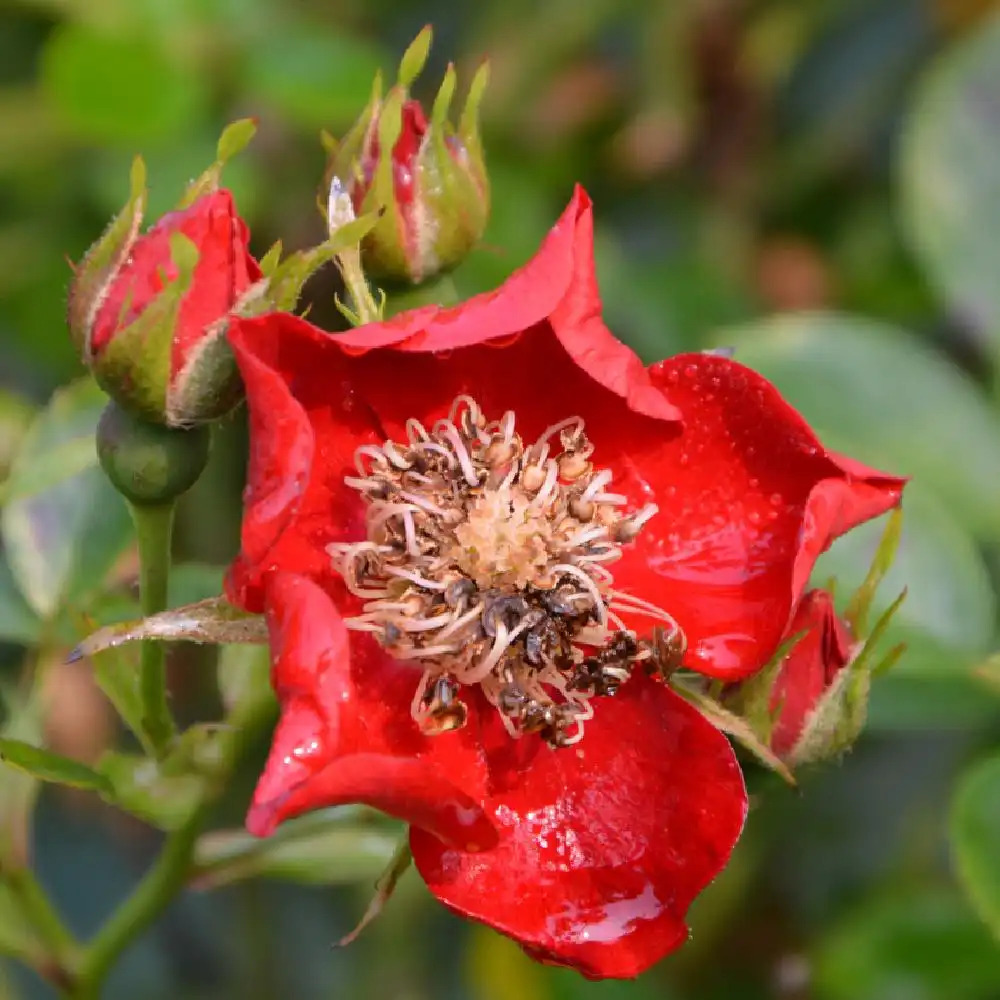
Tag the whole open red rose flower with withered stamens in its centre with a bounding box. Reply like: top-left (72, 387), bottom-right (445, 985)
top-left (228, 190), bottom-right (902, 978)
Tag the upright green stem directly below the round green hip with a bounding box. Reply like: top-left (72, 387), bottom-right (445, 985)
top-left (129, 500), bottom-right (177, 757)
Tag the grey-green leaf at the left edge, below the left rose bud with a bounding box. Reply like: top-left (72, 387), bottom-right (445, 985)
top-left (0, 380), bottom-right (131, 619)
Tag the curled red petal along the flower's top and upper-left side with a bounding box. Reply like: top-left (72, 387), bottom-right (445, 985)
top-left (229, 190), bottom-right (675, 610)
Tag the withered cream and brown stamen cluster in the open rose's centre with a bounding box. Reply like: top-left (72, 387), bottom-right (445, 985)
top-left (328, 396), bottom-right (686, 747)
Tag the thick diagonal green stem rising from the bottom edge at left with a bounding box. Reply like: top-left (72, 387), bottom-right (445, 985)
top-left (72, 801), bottom-right (210, 1000)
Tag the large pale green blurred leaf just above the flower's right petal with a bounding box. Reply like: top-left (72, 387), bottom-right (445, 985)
top-left (713, 313), bottom-right (1000, 538)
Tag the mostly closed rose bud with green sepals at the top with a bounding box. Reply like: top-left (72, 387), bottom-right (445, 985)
top-left (322, 27), bottom-right (489, 284)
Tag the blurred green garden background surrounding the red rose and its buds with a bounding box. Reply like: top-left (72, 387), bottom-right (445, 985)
top-left (0, 0), bottom-right (1000, 1000)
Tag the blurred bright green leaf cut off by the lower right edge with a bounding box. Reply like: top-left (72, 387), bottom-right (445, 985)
top-left (951, 754), bottom-right (1000, 941)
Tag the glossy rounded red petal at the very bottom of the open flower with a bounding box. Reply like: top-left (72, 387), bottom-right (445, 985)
top-left (410, 677), bottom-right (747, 979)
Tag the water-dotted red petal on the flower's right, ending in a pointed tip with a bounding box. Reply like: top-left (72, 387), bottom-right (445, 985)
top-left (595, 354), bottom-right (904, 681)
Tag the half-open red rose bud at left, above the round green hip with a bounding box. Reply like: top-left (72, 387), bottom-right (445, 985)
top-left (68, 123), bottom-right (261, 427)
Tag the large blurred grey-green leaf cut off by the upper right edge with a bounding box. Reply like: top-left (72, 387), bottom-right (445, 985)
top-left (900, 10), bottom-right (1000, 349)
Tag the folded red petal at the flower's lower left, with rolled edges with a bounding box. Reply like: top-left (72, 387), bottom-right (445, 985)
top-left (247, 573), bottom-right (496, 850)
